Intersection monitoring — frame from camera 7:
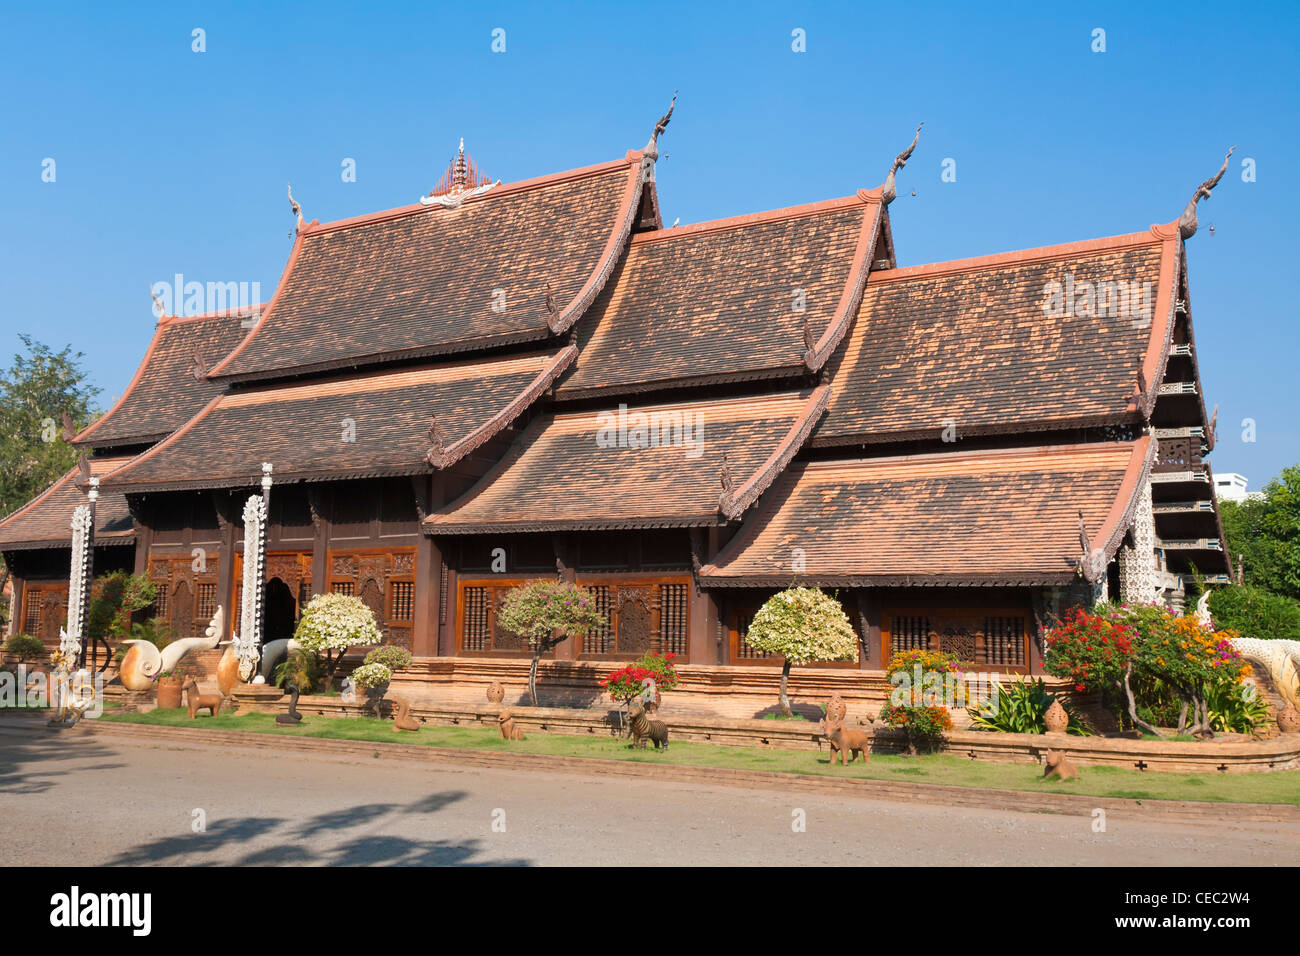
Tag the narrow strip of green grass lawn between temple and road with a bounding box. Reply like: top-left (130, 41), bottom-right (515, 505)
top-left (100, 710), bottom-right (1300, 804)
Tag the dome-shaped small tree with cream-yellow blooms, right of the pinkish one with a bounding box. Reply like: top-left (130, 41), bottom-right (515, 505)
top-left (745, 588), bottom-right (858, 717)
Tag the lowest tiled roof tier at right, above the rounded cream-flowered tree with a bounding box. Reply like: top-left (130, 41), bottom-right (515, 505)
top-left (701, 437), bottom-right (1152, 587)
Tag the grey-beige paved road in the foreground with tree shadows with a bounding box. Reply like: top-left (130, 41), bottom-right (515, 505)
top-left (0, 728), bottom-right (1300, 866)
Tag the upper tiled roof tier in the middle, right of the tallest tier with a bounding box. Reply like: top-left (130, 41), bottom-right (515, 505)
top-left (559, 190), bottom-right (885, 398)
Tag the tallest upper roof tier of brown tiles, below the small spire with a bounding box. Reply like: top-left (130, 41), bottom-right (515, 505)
top-left (212, 152), bottom-right (642, 380)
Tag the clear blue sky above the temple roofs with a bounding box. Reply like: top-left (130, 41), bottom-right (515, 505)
top-left (0, 3), bottom-right (1300, 488)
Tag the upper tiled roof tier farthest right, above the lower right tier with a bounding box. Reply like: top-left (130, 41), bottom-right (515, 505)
top-left (813, 228), bottom-right (1179, 445)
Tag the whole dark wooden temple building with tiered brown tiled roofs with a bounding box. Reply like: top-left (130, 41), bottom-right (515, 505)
top-left (0, 124), bottom-right (1230, 691)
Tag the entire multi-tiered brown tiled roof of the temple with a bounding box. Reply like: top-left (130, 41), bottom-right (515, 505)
top-left (0, 125), bottom-right (1229, 598)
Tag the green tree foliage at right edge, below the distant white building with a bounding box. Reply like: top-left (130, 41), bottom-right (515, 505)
top-left (1219, 464), bottom-right (1300, 600)
